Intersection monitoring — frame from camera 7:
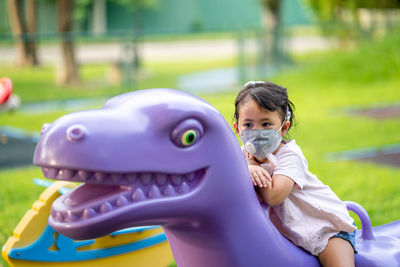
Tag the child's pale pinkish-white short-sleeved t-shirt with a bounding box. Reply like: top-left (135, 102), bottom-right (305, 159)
top-left (245, 140), bottom-right (356, 255)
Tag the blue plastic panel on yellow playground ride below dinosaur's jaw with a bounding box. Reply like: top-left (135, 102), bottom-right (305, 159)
top-left (9, 226), bottom-right (167, 262)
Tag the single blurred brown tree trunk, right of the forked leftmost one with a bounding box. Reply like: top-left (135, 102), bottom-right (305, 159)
top-left (57, 0), bottom-right (80, 85)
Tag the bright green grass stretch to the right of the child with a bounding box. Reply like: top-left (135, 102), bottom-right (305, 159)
top-left (273, 31), bottom-right (400, 225)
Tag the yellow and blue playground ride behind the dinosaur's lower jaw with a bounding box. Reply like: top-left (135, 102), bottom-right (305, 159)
top-left (2, 180), bottom-right (173, 267)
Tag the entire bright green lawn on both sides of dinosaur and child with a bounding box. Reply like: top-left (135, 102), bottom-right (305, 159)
top-left (0, 30), bottom-right (400, 266)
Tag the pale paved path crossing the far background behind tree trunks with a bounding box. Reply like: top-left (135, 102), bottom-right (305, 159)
top-left (0, 36), bottom-right (333, 64)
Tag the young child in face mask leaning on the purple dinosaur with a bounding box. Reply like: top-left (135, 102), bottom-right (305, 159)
top-left (234, 81), bottom-right (357, 266)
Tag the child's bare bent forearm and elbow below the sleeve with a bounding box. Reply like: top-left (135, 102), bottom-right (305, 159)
top-left (260, 174), bottom-right (295, 206)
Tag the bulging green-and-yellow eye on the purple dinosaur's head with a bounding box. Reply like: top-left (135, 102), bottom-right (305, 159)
top-left (171, 119), bottom-right (203, 148)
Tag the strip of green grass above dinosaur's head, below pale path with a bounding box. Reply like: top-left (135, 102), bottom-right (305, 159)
top-left (0, 59), bottom-right (235, 102)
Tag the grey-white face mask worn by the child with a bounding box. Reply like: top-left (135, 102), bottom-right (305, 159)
top-left (240, 109), bottom-right (290, 160)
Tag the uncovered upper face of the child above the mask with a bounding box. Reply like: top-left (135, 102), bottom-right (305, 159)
top-left (233, 97), bottom-right (290, 135)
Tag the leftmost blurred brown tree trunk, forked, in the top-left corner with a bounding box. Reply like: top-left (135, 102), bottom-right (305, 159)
top-left (7, 0), bottom-right (39, 66)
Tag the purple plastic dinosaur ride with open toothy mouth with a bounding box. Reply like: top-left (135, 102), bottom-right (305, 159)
top-left (34, 89), bottom-right (400, 267)
